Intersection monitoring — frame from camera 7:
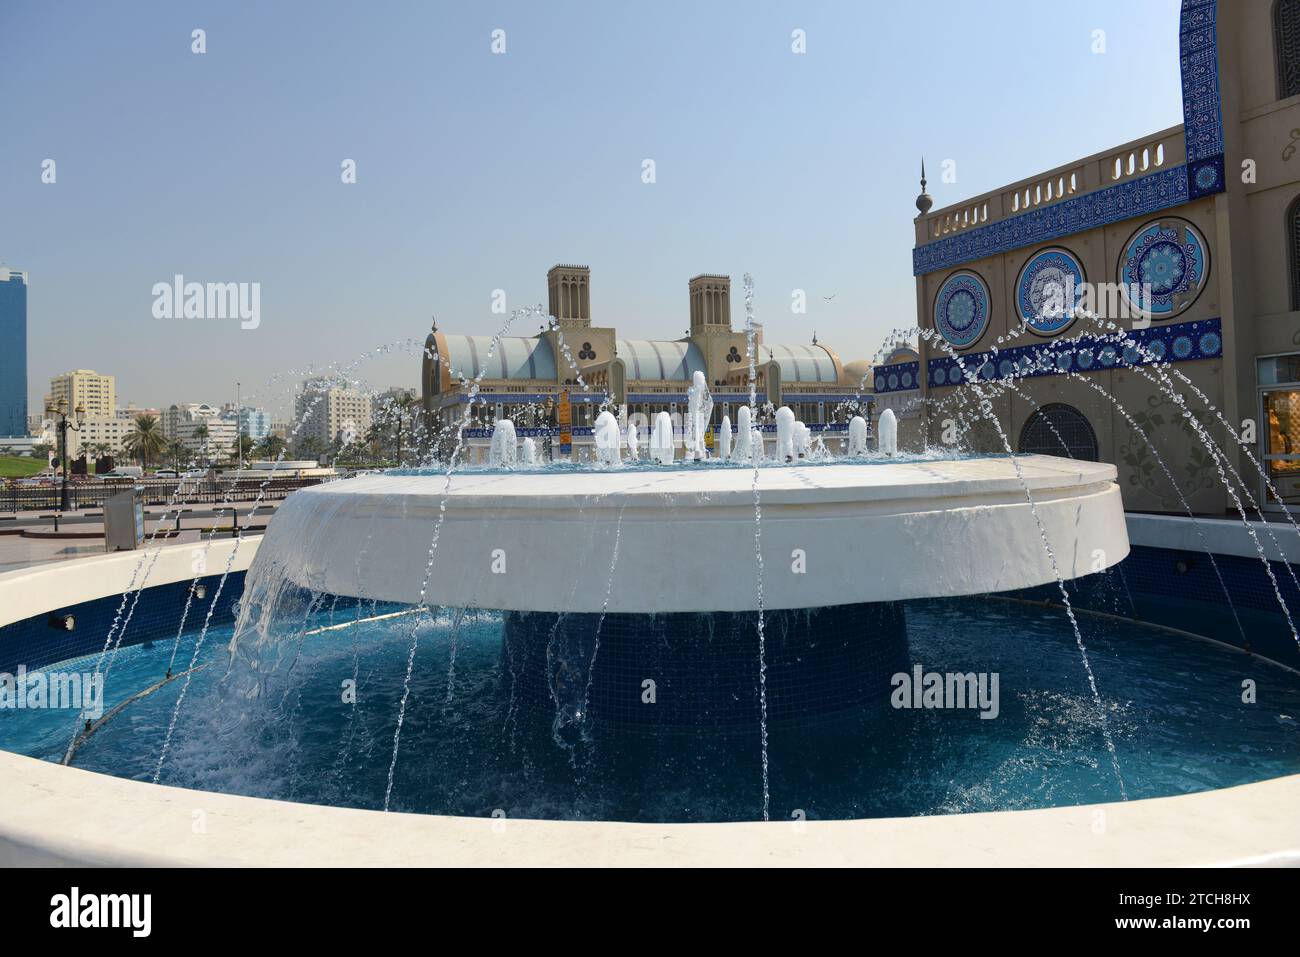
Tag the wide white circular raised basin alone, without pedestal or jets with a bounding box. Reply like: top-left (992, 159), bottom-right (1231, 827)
top-left (261, 455), bottom-right (1128, 614)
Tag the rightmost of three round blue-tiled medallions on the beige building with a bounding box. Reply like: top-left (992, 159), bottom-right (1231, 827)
top-left (1119, 218), bottom-right (1210, 319)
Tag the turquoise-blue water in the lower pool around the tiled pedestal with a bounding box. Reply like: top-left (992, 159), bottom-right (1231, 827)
top-left (0, 598), bottom-right (1300, 822)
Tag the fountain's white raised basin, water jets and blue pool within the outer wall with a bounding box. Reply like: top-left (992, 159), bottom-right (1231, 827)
top-left (10, 317), bottom-right (1294, 863)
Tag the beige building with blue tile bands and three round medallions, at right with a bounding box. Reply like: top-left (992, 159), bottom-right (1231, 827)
top-left (874, 0), bottom-right (1300, 514)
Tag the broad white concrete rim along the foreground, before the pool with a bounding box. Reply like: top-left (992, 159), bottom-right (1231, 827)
top-left (0, 752), bottom-right (1300, 867)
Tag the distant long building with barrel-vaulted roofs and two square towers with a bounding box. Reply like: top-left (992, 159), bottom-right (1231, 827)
top-left (421, 265), bottom-right (871, 451)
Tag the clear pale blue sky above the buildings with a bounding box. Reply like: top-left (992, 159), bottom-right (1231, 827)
top-left (0, 0), bottom-right (1182, 410)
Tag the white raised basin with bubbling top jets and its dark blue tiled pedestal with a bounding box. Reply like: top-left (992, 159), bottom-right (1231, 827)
top-left (231, 416), bottom-right (1128, 729)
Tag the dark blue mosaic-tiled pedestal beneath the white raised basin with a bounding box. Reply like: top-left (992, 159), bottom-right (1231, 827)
top-left (501, 602), bottom-right (910, 731)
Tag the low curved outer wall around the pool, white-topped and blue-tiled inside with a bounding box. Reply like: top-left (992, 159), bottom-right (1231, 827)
top-left (0, 504), bottom-right (1300, 866)
